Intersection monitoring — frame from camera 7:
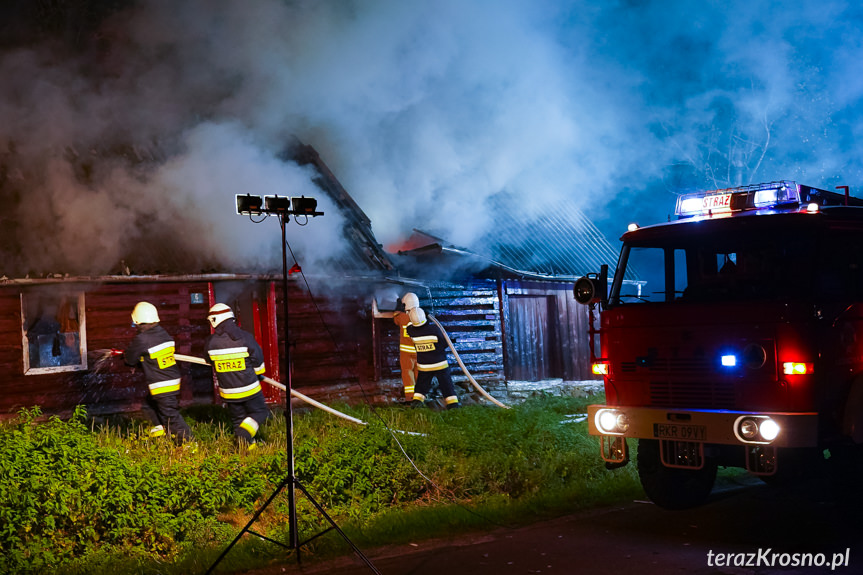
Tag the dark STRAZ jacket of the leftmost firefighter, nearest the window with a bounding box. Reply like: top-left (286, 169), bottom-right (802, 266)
top-left (123, 323), bottom-right (181, 396)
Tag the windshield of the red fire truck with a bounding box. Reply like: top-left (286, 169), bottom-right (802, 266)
top-left (610, 231), bottom-right (819, 305)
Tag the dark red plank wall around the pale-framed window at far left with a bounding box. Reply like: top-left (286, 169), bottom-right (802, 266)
top-left (0, 283), bottom-right (213, 416)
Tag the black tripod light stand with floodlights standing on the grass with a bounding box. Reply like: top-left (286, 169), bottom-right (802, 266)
top-left (207, 194), bottom-right (380, 575)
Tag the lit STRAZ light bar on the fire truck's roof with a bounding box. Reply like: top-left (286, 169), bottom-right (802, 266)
top-left (674, 181), bottom-right (800, 217)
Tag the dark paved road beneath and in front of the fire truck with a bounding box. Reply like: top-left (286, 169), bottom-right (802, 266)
top-left (241, 480), bottom-right (863, 575)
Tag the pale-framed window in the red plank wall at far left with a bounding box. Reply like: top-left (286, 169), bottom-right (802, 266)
top-left (21, 291), bottom-right (87, 375)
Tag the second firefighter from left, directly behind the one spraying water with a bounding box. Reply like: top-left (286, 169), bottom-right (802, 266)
top-left (204, 303), bottom-right (270, 451)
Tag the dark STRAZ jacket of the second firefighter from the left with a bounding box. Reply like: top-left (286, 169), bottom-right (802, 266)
top-left (204, 319), bottom-right (266, 402)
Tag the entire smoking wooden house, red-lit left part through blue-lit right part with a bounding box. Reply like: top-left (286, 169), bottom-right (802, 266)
top-left (0, 142), bottom-right (636, 417)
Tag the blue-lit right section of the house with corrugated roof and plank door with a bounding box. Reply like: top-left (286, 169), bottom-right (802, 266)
top-left (384, 201), bottom-right (639, 393)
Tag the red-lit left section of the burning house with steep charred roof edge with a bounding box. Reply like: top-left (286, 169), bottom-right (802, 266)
top-left (0, 144), bottom-right (394, 417)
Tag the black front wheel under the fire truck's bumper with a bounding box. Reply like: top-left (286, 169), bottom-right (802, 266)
top-left (637, 439), bottom-right (716, 510)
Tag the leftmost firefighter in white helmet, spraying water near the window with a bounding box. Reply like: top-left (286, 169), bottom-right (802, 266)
top-left (123, 301), bottom-right (194, 443)
